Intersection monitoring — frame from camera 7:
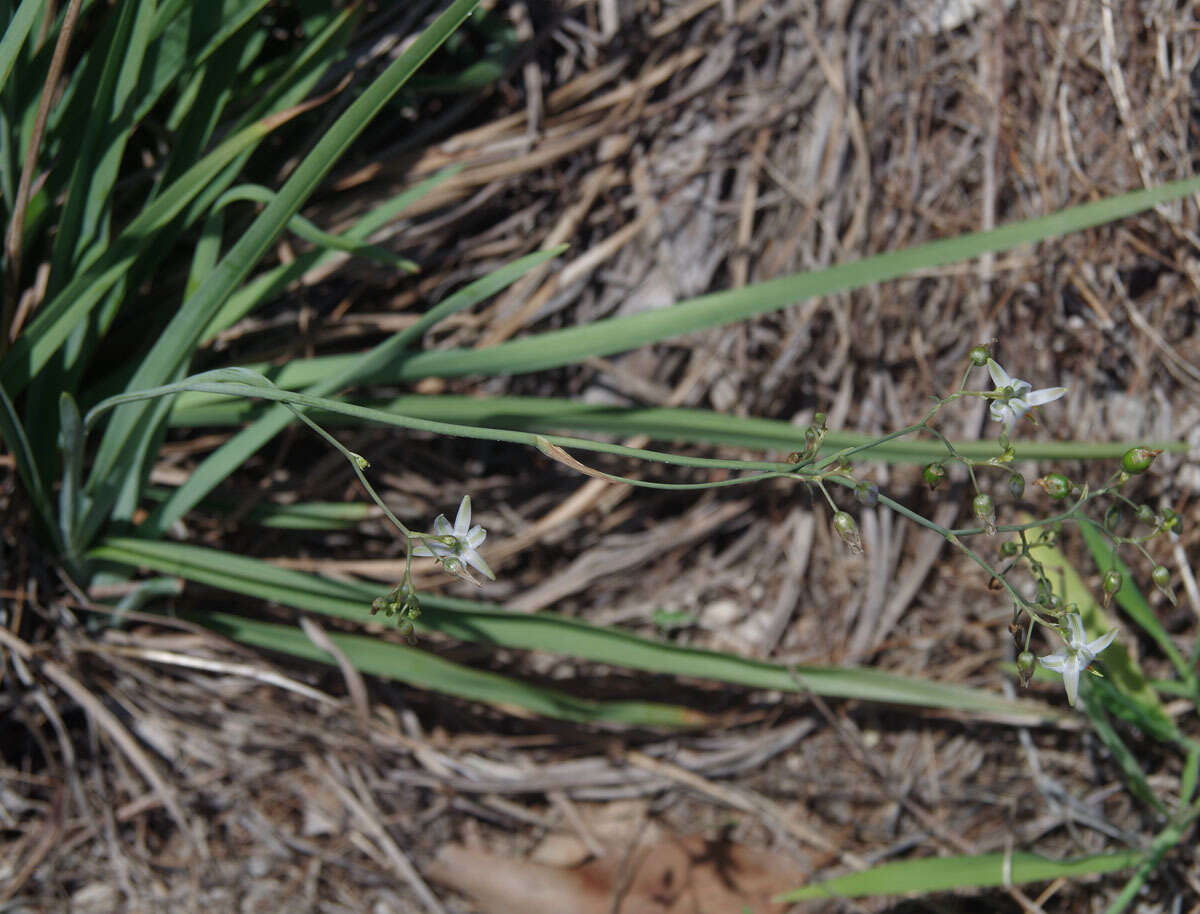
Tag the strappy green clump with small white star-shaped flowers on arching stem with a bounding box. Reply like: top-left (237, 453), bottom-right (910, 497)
top-left (0, 0), bottom-right (1200, 902)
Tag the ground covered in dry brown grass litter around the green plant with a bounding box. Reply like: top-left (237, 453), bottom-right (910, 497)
top-left (0, 0), bottom-right (1200, 914)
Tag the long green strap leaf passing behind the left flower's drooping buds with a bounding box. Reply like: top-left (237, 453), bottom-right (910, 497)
top-left (89, 537), bottom-right (1061, 724)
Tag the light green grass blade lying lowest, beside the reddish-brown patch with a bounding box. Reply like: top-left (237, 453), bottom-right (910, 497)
top-left (775, 850), bottom-right (1142, 903)
